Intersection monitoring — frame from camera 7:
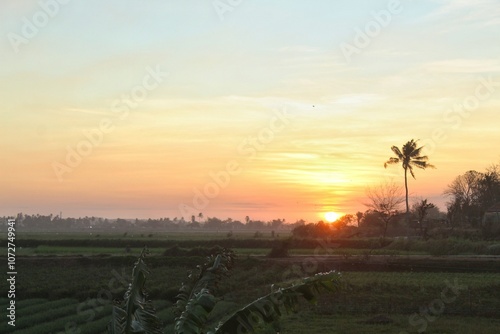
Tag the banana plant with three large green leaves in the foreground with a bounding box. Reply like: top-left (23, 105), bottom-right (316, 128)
top-left (108, 249), bottom-right (340, 334)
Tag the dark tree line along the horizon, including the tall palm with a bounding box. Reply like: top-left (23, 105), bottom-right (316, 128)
top-left (2, 139), bottom-right (500, 238)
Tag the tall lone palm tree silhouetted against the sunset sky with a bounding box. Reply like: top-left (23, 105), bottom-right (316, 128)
top-left (384, 139), bottom-right (436, 223)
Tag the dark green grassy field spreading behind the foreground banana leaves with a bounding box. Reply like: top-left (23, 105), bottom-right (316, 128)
top-left (0, 234), bottom-right (500, 334)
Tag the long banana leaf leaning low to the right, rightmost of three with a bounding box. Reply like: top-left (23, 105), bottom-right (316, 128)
top-left (209, 271), bottom-right (340, 334)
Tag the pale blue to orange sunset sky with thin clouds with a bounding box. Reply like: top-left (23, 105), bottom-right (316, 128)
top-left (0, 0), bottom-right (500, 222)
